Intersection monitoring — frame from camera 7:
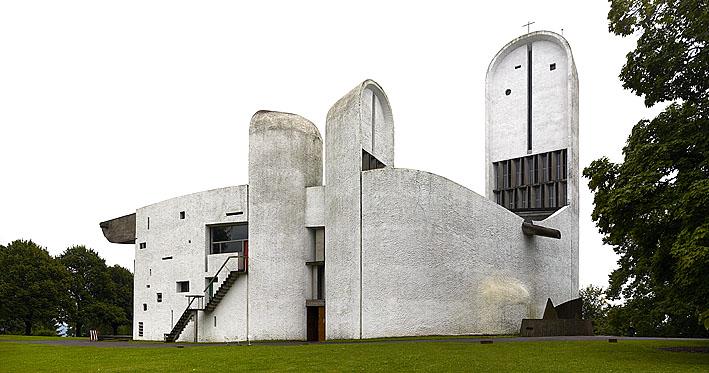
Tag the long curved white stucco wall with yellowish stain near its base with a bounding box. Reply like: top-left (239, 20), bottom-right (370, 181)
top-left (362, 168), bottom-right (577, 338)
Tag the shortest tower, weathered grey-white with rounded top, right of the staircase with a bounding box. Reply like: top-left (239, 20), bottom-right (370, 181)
top-left (248, 111), bottom-right (322, 339)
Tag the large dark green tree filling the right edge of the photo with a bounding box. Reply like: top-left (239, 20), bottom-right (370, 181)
top-left (583, 0), bottom-right (709, 335)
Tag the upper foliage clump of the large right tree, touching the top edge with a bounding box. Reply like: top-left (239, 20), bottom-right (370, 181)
top-left (608, 0), bottom-right (709, 106)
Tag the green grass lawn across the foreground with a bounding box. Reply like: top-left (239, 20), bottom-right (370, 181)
top-left (0, 341), bottom-right (709, 373)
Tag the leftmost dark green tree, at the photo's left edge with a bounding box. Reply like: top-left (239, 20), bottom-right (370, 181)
top-left (0, 240), bottom-right (69, 335)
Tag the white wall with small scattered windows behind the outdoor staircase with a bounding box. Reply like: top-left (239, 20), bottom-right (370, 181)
top-left (133, 185), bottom-right (248, 340)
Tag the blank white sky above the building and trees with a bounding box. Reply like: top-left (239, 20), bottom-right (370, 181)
top-left (0, 0), bottom-right (657, 287)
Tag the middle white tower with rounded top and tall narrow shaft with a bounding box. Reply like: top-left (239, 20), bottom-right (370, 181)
top-left (325, 80), bottom-right (394, 339)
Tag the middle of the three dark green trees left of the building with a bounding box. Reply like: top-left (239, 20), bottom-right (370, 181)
top-left (59, 246), bottom-right (112, 337)
